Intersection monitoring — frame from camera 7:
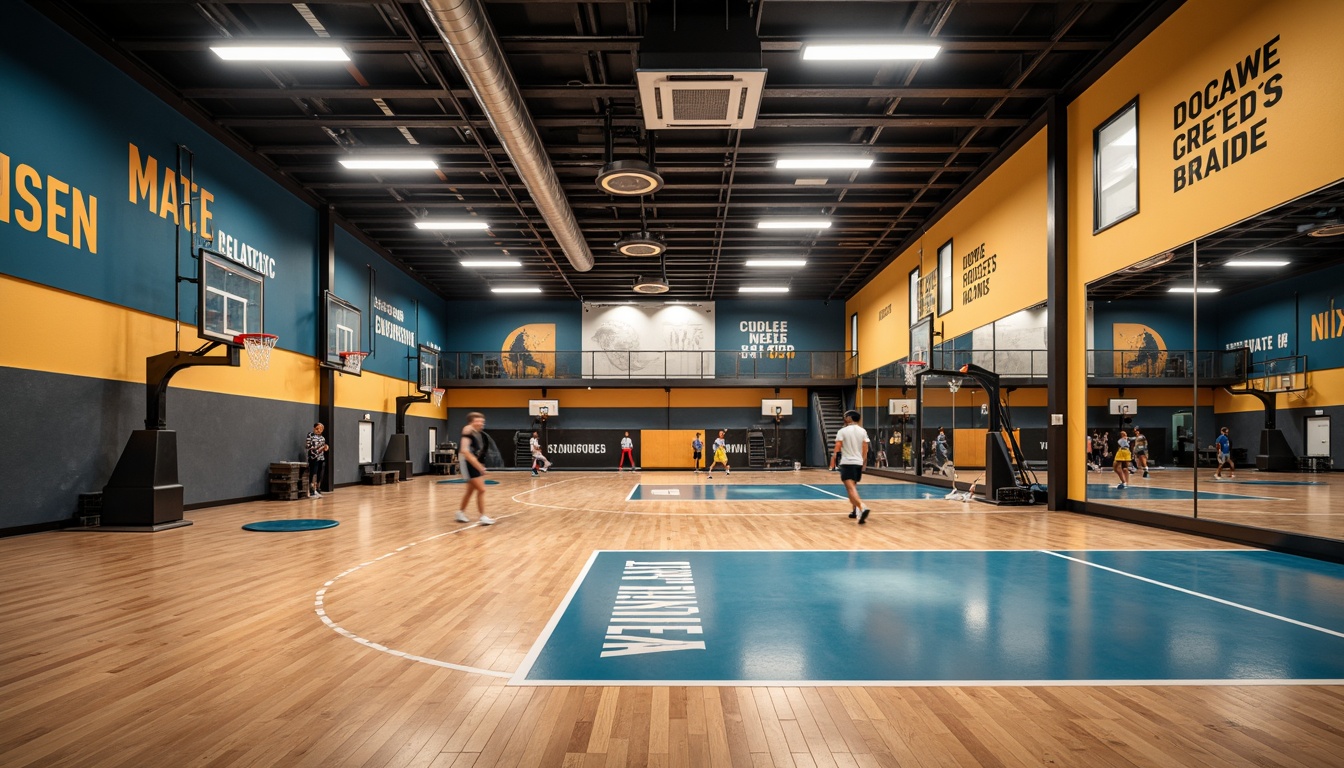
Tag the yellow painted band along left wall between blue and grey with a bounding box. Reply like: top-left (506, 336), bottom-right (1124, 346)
top-left (0, 270), bottom-right (424, 416)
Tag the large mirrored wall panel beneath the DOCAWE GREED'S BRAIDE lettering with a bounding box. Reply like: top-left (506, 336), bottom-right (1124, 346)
top-left (1079, 184), bottom-right (1344, 539)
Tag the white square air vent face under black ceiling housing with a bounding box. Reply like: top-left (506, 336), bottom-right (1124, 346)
top-left (634, 70), bottom-right (765, 130)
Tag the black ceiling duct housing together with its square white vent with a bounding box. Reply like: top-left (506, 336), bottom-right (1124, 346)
top-left (634, 1), bottom-right (766, 130)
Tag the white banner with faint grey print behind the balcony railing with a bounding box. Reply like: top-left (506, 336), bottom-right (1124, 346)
top-left (583, 301), bottom-right (714, 378)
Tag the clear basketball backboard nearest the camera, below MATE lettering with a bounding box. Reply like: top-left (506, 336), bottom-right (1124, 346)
top-left (196, 249), bottom-right (265, 346)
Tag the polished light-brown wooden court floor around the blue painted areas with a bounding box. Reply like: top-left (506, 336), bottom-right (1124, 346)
top-left (0, 472), bottom-right (1344, 768)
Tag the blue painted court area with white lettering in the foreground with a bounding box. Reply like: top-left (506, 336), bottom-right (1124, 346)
top-left (512, 550), bottom-right (1344, 685)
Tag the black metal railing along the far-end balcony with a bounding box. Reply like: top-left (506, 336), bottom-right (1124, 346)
top-left (438, 350), bottom-right (857, 382)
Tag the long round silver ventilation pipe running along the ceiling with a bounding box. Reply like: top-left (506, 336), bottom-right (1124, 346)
top-left (421, 0), bottom-right (593, 272)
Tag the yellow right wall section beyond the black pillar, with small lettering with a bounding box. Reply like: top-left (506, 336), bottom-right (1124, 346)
top-left (845, 130), bottom-right (1047, 371)
